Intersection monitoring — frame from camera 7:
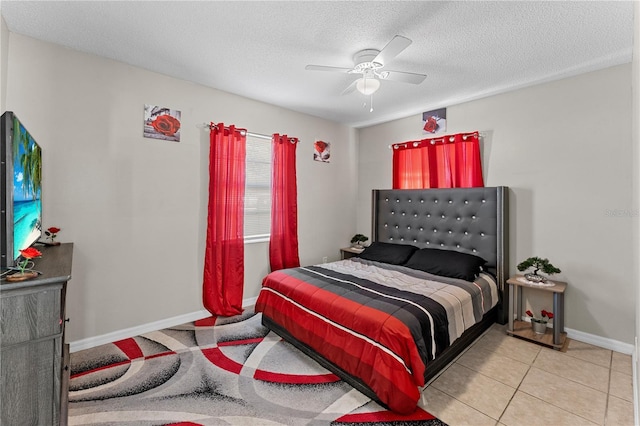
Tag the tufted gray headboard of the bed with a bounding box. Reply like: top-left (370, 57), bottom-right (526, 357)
top-left (372, 186), bottom-right (509, 320)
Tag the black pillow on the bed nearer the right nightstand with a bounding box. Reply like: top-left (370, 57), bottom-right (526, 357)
top-left (404, 249), bottom-right (487, 281)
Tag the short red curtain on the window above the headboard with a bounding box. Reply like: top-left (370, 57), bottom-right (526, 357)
top-left (393, 132), bottom-right (484, 189)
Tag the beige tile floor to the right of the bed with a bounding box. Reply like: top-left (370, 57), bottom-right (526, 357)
top-left (423, 324), bottom-right (634, 426)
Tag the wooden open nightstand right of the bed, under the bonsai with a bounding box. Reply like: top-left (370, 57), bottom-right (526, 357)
top-left (507, 275), bottom-right (567, 350)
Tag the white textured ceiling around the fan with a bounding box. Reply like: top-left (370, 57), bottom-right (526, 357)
top-left (0, 0), bottom-right (633, 127)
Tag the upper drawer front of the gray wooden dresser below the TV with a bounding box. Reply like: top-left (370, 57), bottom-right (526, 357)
top-left (0, 285), bottom-right (62, 347)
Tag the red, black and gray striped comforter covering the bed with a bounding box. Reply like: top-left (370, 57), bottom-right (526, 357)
top-left (256, 258), bottom-right (498, 413)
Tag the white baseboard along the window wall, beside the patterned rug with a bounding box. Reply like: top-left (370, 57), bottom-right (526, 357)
top-left (69, 297), bottom-right (258, 352)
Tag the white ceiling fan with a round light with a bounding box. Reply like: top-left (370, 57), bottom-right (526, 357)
top-left (305, 35), bottom-right (427, 95)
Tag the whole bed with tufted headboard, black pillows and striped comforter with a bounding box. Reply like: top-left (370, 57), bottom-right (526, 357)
top-left (256, 187), bottom-right (508, 413)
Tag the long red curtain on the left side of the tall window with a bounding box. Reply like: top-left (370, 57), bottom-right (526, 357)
top-left (202, 123), bottom-right (246, 316)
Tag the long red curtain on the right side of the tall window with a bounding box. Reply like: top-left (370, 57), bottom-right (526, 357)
top-left (269, 133), bottom-right (300, 271)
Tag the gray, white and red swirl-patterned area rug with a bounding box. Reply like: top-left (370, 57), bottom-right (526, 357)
top-left (69, 310), bottom-right (446, 426)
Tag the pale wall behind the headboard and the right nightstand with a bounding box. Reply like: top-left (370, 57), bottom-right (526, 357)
top-left (357, 64), bottom-right (635, 344)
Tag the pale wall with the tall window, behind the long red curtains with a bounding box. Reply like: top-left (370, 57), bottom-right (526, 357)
top-left (6, 33), bottom-right (357, 341)
